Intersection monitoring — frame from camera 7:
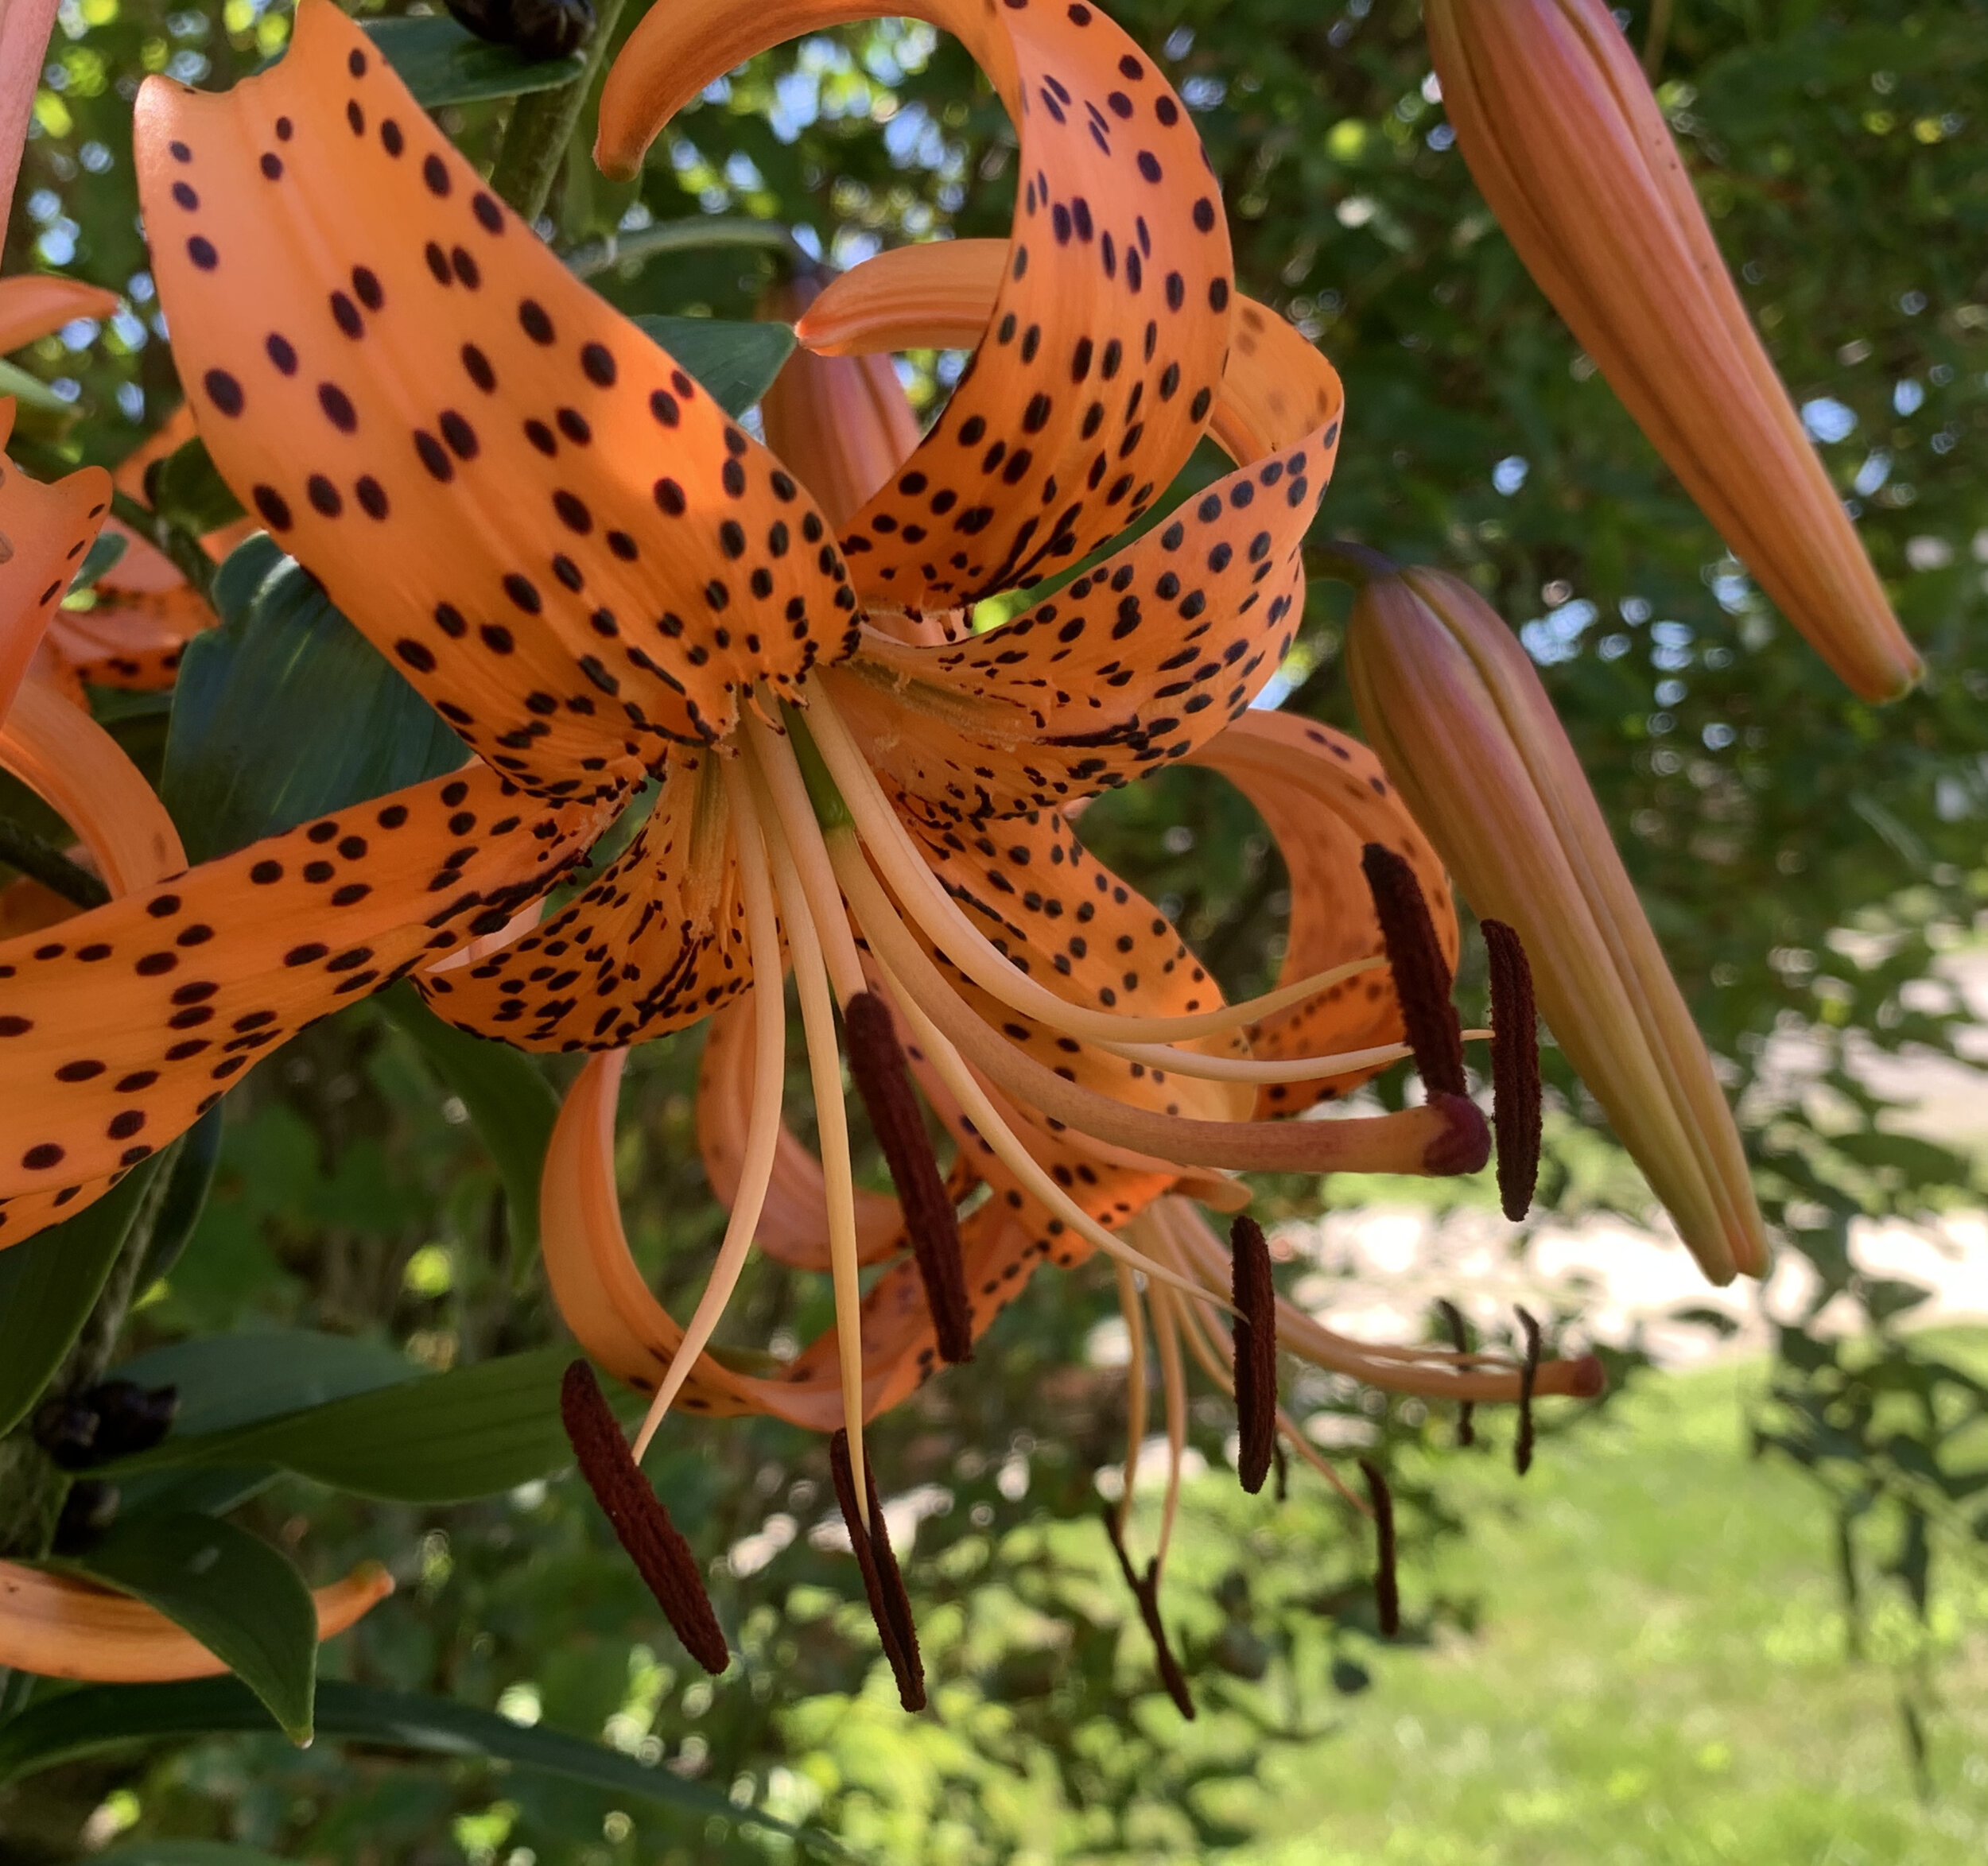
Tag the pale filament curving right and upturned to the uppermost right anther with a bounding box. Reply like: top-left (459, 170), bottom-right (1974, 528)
top-left (790, 681), bottom-right (1388, 1043)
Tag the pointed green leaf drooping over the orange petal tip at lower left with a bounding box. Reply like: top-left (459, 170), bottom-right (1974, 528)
top-left (64, 1515), bottom-right (318, 1745)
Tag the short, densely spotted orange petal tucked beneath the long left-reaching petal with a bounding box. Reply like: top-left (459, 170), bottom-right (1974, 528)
top-left (416, 753), bottom-right (751, 1049)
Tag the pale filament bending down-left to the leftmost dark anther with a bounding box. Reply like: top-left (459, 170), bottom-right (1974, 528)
top-left (635, 759), bottom-right (791, 1463)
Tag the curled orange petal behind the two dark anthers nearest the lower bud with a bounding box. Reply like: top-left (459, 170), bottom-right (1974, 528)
top-left (1193, 712), bottom-right (1458, 1117)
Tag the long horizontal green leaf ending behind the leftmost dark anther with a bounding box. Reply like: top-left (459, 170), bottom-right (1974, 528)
top-left (102, 1344), bottom-right (643, 1503)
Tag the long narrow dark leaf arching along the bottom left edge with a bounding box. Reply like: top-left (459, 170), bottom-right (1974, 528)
top-left (0, 1678), bottom-right (849, 1858)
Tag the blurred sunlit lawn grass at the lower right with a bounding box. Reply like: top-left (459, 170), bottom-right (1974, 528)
top-left (1225, 1337), bottom-right (1988, 1866)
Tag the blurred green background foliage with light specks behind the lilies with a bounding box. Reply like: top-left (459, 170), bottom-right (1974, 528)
top-left (0, 0), bottom-right (1988, 1866)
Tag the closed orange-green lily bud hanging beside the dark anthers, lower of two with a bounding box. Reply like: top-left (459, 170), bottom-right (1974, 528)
top-left (1346, 570), bottom-right (1768, 1284)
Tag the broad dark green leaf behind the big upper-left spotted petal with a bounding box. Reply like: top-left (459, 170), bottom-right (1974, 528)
top-left (159, 537), bottom-right (468, 863)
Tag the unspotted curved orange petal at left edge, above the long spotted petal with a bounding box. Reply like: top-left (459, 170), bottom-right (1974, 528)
top-left (0, 681), bottom-right (187, 894)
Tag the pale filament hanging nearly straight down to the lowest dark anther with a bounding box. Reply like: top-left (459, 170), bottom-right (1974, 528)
top-left (747, 762), bottom-right (869, 1528)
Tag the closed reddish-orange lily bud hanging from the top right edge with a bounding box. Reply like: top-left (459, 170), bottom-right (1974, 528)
top-left (1423, 0), bottom-right (1920, 700)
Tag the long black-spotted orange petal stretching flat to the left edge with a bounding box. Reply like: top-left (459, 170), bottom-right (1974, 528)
top-left (0, 767), bottom-right (600, 1244)
